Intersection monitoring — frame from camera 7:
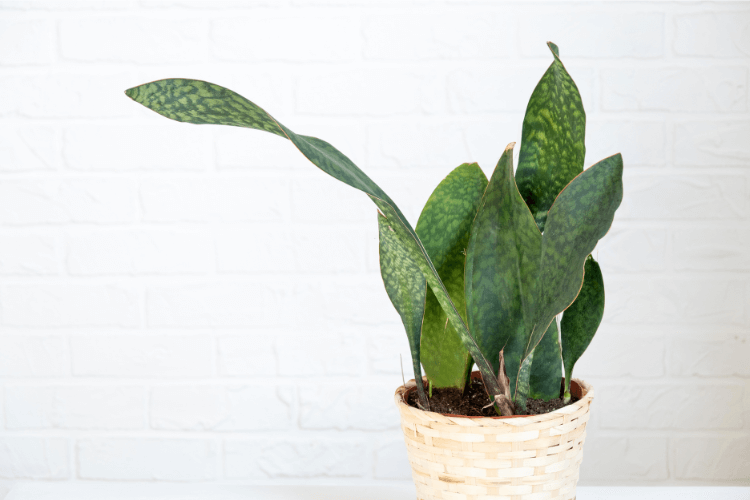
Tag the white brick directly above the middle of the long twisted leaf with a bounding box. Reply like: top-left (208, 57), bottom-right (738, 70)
top-left (296, 69), bottom-right (445, 116)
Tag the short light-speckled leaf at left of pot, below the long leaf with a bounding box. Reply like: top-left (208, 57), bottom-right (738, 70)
top-left (378, 212), bottom-right (430, 409)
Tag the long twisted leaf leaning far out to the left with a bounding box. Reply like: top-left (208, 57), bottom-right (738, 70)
top-left (125, 79), bottom-right (508, 404)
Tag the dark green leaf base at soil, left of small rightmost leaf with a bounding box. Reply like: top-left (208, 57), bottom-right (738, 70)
top-left (529, 319), bottom-right (562, 401)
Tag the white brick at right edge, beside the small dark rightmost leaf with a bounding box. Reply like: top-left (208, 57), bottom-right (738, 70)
top-left (604, 277), bottom-right (747, 326)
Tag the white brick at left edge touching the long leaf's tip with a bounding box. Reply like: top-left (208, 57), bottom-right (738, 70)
top-left (0, 70), bottom-right (136, 118)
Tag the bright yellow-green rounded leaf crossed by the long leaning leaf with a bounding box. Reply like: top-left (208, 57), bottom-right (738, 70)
top-left (417, 163), bottom-right (487, 390)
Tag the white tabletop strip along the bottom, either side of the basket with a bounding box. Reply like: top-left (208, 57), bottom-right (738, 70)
top-left (5, 482), bottom-right (750, 500)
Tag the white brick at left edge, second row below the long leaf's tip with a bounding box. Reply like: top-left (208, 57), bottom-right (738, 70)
top-left (0, 179), bottom-right (136, 225)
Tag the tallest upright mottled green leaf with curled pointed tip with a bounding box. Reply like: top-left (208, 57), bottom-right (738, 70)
top-left (516, 42), bottom-right (586, 231)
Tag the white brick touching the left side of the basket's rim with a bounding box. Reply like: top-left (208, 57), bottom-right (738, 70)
top-left (299, 384), bottom-right (400, 431)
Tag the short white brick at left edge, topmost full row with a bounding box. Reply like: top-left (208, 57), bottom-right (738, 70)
top-left (0, 16), bottom-right (55, 66)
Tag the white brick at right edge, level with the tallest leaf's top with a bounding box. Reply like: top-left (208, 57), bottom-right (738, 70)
top-left (600, 66), bottom-right (747, 113)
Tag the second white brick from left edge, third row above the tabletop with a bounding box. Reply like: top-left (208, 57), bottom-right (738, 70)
top-left (70, 335), bottom-right (214, 378)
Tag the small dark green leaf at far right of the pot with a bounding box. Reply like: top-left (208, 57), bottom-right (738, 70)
top-left (560, 255), bottom-right (604, 398)
